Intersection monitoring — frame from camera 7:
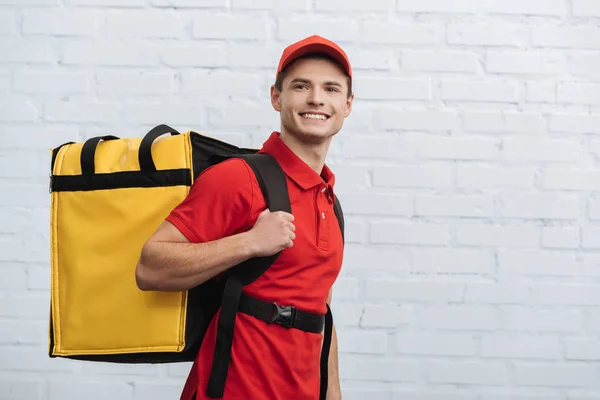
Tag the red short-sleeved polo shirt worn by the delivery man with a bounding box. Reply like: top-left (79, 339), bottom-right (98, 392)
top-left (167, 132), bottom-right (343, 400)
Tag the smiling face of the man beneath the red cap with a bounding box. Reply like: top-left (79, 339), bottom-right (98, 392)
top-left (271, 59), bottom-right (354, 144)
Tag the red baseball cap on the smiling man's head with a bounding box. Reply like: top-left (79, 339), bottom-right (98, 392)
top-left (275, 35), bottom-right (352, 79)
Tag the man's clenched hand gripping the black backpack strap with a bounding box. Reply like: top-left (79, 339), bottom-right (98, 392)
top-left (248, 209), bottom-right (296, 257)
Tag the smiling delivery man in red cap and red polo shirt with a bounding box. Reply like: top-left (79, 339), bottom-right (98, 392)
top-left (136, 36), bottom-right (354, 400)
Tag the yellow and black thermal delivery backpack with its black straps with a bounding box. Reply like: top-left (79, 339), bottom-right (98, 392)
top-left (49, 125), bottom-right (344, 398)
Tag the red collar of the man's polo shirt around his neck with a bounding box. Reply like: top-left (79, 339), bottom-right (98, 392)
top-left (260, 132), bottom-right (335, 195)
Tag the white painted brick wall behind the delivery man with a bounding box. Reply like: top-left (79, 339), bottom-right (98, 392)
top-left (0, 0), bottom-right (600, 400)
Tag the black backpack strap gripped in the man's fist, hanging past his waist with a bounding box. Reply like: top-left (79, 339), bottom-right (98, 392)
top-left (206, 154), bottom-right (292, 398)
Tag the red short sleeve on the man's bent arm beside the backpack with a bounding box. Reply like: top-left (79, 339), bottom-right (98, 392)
top-left (166, 159), bottom-right (258, 243)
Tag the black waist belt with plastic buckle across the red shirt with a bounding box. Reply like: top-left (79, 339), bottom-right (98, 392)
top-left (238, 293), bottom-right (325, 333)
